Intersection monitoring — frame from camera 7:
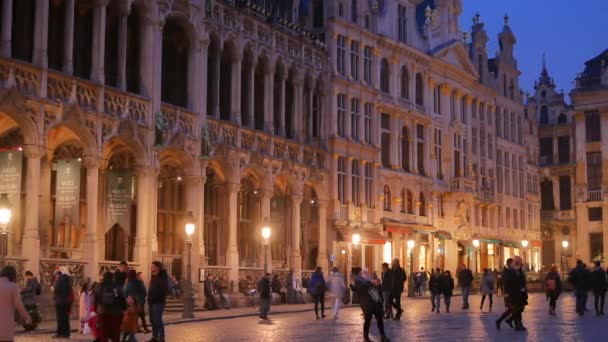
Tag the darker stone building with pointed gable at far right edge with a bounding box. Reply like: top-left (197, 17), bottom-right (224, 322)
top-left (529, 51), bottom-right (608, 268)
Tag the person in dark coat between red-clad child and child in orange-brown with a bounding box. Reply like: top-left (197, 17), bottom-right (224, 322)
top-left (95, 272), bottom-right (126, 342)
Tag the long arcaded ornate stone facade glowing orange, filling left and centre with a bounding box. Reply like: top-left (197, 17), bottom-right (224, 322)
top-left (0, 0), bottom-right (540, 296)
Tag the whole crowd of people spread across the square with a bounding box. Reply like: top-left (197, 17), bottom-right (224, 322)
top-left (0, 252), bottom-right (608, 342)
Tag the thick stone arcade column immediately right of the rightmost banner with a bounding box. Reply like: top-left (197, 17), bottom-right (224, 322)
top-left (133, 166), bottom-right (157, 279)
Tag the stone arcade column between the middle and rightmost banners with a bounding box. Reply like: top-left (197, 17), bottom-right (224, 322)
top-left (83, 157), bottom-right (101, 279)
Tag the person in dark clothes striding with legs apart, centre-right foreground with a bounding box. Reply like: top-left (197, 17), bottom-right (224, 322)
top-left (350, 267), bottom-right (390, 342)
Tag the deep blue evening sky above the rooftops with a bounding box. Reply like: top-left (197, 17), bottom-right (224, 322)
top-left (460, 0), bottom-right (608, 98)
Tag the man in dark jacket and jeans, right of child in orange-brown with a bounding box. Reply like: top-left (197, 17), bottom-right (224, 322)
top-left (148, 261), bottom-right (169, 342)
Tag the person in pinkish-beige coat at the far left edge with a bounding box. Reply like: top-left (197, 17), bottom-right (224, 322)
top-left (0, 266), bottom-right (31, 341)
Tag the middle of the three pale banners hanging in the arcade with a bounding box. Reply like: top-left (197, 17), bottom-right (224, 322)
top-left (55, 159), bottom-right (80, 235)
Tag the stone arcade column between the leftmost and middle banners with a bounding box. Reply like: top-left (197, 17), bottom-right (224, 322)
top-left (22, 145), bottom-right (44, 275)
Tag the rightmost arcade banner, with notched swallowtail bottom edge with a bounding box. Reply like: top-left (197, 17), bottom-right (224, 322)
top-left (106, 169), bottom-right (133, 232)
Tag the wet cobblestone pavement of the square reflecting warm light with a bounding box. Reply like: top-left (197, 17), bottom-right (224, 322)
top-left (15, 293), bottom-right (608, 342)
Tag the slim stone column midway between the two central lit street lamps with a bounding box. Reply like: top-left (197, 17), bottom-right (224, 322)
top-left (226, 183), bottom-right (241, 284)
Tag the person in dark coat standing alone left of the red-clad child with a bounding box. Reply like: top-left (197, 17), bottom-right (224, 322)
top-left (53, 270), bottom-right (74, 338)
